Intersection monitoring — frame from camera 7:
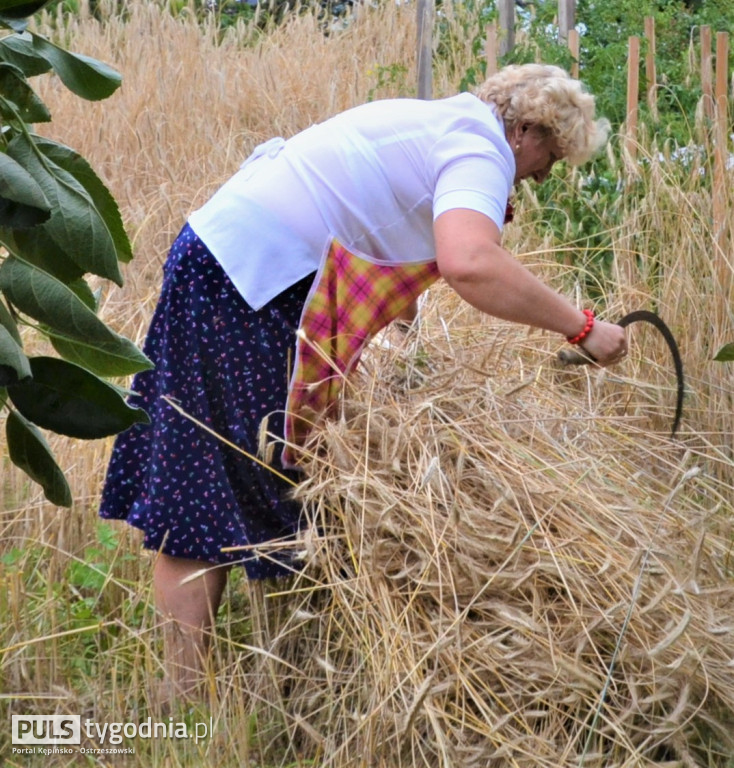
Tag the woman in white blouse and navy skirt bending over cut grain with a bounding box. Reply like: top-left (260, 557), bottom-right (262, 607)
top-left (100, 64), bottom-right (626, 692)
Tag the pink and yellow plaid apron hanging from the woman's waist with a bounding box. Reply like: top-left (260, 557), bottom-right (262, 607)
top-left (283, 240), bottom-right (439, 466)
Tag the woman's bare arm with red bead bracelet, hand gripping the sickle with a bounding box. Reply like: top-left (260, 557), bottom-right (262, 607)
top-left (433, 208), bottom-right (627, 365)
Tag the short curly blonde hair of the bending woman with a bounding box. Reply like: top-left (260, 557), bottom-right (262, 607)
top-left (476, 64), bottom-right (609, 165)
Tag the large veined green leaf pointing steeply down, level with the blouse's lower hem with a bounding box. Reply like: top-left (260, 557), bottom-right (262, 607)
top-left (8, 135), bottom-right (122, 285)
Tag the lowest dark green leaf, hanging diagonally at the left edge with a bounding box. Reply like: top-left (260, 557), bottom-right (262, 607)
top-left (5, 411), bottom-right (71, 507)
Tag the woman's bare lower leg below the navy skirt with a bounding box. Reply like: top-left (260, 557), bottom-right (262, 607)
top-left (153, 554), bottom-right (229, 698)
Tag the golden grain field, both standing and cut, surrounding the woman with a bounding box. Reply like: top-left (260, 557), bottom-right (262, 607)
top-left (0, 3), bottom-right (734, 767)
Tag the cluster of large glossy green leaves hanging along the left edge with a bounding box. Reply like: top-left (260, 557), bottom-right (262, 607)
top-left (0, 0), bottom-right (151, 506)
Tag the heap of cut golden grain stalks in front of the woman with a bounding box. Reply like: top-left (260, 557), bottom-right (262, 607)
top-left (246, 286), bottom-right (734, 768)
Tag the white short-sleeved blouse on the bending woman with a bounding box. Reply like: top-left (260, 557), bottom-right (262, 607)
top-left (189, 93), bottom-right (515, 309)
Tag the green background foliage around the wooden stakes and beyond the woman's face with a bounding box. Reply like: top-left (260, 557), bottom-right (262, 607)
top-left (457, 0), bottom-right (734, 304)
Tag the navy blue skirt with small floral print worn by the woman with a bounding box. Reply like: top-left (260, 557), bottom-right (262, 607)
top-left (99, 225), bottom-right (313, 579)
